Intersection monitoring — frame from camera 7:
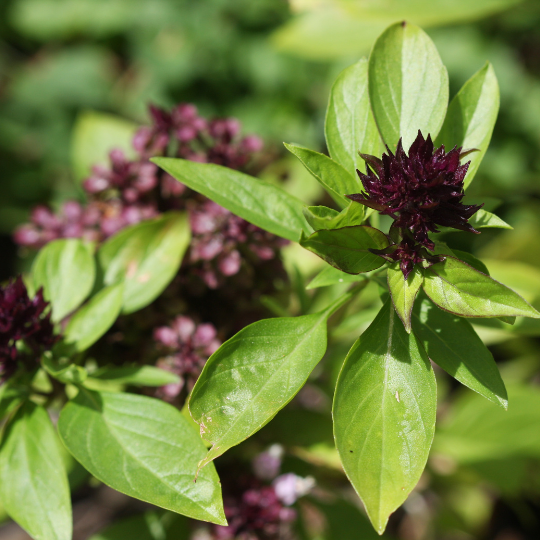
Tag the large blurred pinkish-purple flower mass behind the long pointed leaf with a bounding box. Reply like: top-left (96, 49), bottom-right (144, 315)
top-left (14, 103), bottom-right (285, 288)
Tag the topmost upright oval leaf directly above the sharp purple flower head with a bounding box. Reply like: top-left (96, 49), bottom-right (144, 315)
top-left (369, 22), bottom-right (448, 151)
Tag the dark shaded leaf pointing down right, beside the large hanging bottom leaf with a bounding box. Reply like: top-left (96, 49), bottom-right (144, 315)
top-left (413, 297), bottom-right (508, 409)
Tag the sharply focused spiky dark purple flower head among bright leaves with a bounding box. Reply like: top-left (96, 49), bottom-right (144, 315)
top-left (347, 131), bottom-right (481, 276)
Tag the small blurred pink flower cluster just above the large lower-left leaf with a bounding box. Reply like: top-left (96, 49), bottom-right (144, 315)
top-left (154, 316), bottom-right (221, 401)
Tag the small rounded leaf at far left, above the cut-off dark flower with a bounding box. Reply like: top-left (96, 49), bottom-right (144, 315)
top-left (32, 238), bottom-right (96, 322)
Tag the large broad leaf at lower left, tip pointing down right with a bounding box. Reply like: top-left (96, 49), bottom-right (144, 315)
top-left (58, 389), bottom-right (227, 525)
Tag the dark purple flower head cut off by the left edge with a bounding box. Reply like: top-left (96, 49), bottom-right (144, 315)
top-left (0, 276), bottom-right (58, 382)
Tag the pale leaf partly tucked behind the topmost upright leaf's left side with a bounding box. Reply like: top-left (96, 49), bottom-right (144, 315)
top-left (324, 58), bottom-right (384, 177)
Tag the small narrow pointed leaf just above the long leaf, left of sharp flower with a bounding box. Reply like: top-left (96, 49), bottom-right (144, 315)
top-left (284, 143), bottom-right (356, 208)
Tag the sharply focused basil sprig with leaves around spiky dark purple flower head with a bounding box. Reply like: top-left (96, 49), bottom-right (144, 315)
top-left (153, 23), bottom-right (540, 534)
